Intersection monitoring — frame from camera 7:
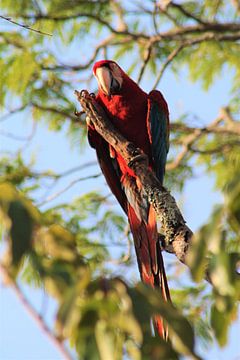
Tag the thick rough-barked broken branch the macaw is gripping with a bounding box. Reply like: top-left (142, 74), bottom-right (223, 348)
top-left (75, 90), bottom-right (193, 263)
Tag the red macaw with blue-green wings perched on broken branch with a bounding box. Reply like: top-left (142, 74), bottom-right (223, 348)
top-left (87, 60), bottom-right (171, 339)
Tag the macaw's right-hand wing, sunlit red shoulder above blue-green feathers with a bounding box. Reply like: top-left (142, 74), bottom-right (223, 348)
top-left (147, 90), bottom-right (169, 183)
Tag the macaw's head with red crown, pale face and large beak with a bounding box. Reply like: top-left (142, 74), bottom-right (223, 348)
top-left (93, 60), bottom-right (125, 96)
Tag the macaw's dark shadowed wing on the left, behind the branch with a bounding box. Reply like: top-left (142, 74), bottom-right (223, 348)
top-left (88, 128), bottom-right (127, 212)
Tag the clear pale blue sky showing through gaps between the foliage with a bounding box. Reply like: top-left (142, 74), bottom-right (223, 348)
top-left (0, 34), bottom-right (240, 360)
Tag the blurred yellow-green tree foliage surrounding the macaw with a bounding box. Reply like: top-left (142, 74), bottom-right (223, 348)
top-left (0, 0), bottom-right (240, 359)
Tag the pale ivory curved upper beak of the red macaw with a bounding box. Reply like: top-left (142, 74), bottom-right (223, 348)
top-left (96, 66), bottom-right (120, 96)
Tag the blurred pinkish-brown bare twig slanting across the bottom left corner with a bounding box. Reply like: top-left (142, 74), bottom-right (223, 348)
top-left (0, 262), bottom-right (72, 360)
